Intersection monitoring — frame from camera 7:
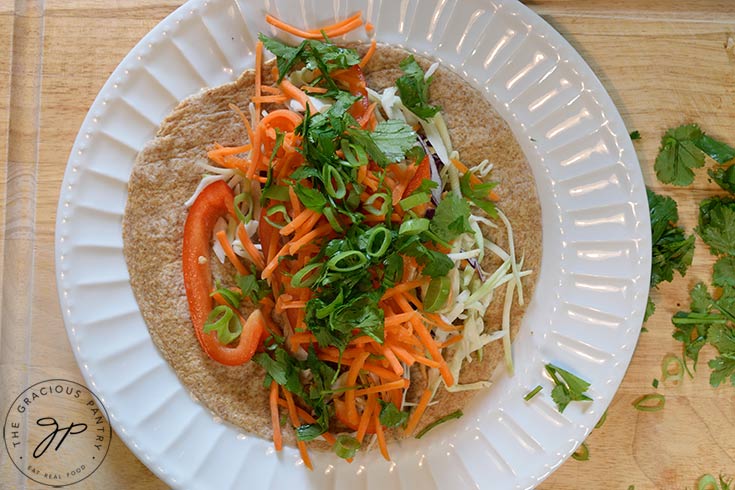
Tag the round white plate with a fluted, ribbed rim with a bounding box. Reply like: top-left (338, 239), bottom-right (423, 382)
top-left (56, 0), bottom-right (651, 490)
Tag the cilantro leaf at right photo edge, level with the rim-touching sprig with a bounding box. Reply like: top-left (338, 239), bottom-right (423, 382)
top-left (696, 197), bottom-right (735, 255)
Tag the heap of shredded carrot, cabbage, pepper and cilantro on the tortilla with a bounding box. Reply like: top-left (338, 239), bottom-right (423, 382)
top-left (184, 14), bottom-right (532, 468)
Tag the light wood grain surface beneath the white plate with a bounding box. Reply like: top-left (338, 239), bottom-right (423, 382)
top-left (0, 0), bottom-right (735, 490)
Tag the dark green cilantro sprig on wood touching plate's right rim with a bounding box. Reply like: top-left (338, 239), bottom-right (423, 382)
top-left (646, 189), bottom-right (694, 287)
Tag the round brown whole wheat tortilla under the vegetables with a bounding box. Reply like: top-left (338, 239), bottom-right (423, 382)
top-left (123, 46), bottom-right (541, 444)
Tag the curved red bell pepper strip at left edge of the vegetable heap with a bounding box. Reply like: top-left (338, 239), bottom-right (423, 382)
top-left (182, 181), bottom-right (265, 366)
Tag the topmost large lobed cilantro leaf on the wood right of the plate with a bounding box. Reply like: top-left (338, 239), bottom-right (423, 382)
top-left (653, 124), bottom-right (704, 186)
